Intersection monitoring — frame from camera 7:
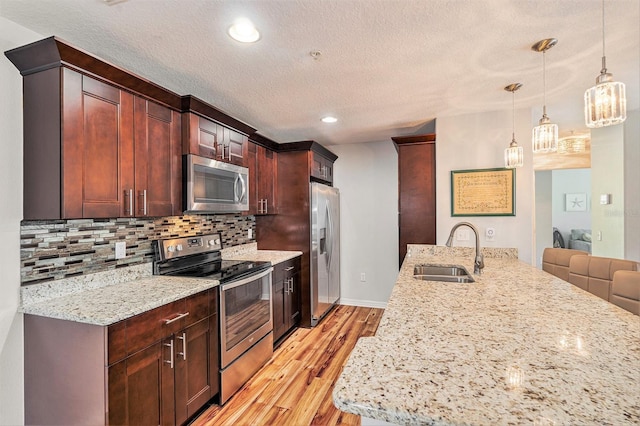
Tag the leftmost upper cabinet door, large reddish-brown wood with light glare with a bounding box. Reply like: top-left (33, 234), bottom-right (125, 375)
top-left (62, 68), bottom-right (134, 218)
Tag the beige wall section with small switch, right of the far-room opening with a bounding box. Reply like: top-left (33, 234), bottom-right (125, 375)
top-left (591, 121), bottom-right (624, 259)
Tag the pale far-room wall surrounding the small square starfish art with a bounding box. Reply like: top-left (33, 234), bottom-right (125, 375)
top-left (552, 169), bottom-right (598, 248)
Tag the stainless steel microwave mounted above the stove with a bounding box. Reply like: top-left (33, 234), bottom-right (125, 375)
top-left (183, 154), bottom-right (249, 213)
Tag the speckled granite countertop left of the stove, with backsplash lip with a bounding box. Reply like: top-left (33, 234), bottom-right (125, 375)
top-left (19, 264), bottom-right (219, 326)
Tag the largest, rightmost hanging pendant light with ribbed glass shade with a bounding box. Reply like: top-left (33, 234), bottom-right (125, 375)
top-left (584, 0), bottom-right (627, 128)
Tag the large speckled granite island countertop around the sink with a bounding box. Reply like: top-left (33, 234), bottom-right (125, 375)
top-left (333, 246), bottom-right (640, 425)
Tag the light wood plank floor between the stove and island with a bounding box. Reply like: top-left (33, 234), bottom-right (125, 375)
top-left (193, 305), bottom-right (383, 426)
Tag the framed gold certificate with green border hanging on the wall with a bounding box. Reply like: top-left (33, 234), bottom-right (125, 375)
top-left (451, 168), bottom-right (516, 216)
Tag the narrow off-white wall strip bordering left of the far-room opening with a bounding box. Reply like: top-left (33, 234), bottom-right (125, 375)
top-left (535, 170), bottom-right (553, 269)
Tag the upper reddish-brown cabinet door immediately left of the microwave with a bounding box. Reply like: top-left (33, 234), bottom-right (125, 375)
top-left (134, 97), bottom-right (182, 217)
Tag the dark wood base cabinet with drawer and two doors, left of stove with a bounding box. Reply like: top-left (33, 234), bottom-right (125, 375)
top-left (25, 289), bottom-right (219, 425)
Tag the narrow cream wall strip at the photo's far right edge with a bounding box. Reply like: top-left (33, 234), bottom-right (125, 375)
top-left (624, 110), bottom-right (640, 262)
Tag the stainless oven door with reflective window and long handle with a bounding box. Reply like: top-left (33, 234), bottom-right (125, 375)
top-left (220, 268), bottom-right (273, 369)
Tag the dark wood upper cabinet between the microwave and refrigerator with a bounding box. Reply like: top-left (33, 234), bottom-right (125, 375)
top-left (247, 134), bottom-right (278, 215)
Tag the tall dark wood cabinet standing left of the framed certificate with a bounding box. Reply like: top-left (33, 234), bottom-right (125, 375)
top-left (391, 134), bottom-right (436, 265)
